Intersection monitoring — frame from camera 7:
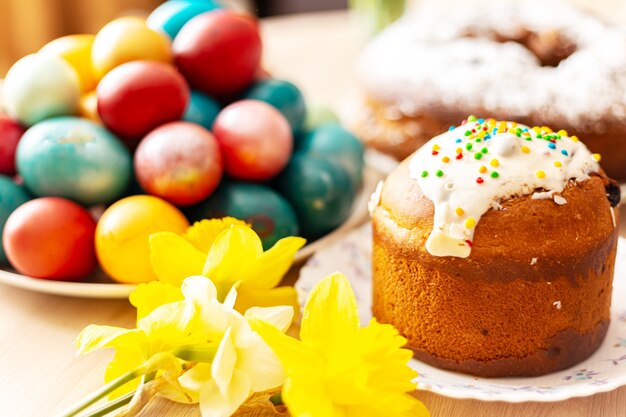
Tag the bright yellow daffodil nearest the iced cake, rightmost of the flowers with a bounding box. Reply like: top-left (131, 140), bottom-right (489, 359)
top-left (252, 274), bottom-right (429, 417)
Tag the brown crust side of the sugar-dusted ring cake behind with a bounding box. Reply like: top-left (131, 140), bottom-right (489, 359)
top-left (354, 99), bottom-right (626, 180)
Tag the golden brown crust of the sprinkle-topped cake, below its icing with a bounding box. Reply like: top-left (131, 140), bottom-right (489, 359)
top-left (373, 161), bottom-right (618, 376)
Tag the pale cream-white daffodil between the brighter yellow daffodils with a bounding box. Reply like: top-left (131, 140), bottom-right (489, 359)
top-left (171, 277), bottom-right (293, 417)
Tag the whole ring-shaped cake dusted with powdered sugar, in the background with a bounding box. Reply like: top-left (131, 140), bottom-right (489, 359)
top-left (356, 1), bottom-right (626, 179)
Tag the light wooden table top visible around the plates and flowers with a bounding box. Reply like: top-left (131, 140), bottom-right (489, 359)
top-left (0, 7), bottom-right (626, 417)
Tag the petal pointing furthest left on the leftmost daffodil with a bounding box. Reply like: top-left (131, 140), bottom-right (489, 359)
top-left (74, 324), bottom-right (145, 354)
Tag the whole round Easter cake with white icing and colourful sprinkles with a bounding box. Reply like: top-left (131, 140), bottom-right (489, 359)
top-left (372, 117), bottom-right (620, 377)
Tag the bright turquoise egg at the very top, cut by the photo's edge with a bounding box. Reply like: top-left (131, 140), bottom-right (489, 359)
top-left (147, 0), bottom-right (221, 39)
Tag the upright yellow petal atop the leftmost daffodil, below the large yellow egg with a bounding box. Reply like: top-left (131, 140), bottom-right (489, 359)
top-left (137, 301), bottom-right (199, 352)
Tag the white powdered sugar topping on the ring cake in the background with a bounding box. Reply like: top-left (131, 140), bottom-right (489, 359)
top-left (358, 0), bottom-right (626, 133)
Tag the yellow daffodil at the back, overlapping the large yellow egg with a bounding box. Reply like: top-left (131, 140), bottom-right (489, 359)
top-left (150, 218), bottom-right (305, 312)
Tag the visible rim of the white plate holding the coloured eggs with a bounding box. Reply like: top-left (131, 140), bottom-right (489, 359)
top-left (0, 168), bottom-right (382, 298)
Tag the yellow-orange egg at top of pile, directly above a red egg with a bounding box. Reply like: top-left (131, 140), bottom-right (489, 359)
top-left (91, 17), bottom-right (172, 79)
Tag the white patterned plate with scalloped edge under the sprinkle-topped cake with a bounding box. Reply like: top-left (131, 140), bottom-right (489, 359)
top-left (296, 224), bottom-right (626, 402)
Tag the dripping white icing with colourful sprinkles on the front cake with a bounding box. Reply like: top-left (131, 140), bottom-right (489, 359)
top-left (409, 118), bottom-right (599, 258)
